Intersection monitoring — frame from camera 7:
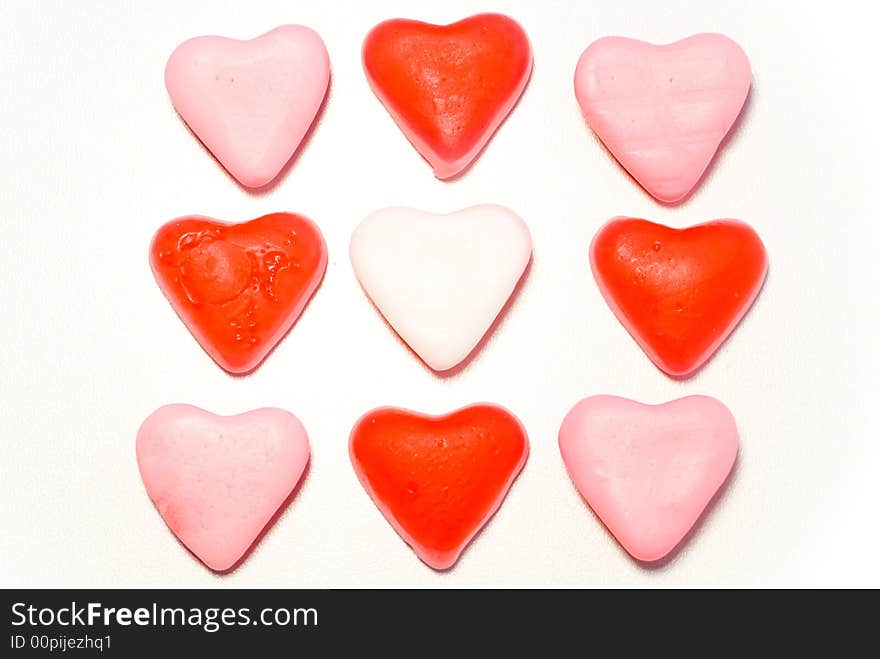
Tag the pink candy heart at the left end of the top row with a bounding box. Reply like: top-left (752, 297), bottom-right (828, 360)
top-left (165, 25), bottom-right (330, 188)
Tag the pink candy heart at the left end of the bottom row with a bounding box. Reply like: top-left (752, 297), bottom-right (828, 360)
top-left (137, 405), bottom-right (309, 572)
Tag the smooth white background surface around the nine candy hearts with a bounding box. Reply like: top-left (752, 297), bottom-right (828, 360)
top-left (0, 0), bottom-right (880, 587)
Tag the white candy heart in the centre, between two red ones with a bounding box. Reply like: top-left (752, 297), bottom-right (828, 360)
top-left (351, 205), bottom-right (532, 371)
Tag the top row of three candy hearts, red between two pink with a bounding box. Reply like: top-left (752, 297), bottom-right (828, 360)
top-left (165, 14), bottom-right (751, 202)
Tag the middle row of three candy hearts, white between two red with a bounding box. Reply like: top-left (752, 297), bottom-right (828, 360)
top-left (150, 205), bottom-right (767, 377)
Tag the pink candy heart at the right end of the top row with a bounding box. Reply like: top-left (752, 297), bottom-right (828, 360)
top-left (574, 34), bottom-right (752, 202)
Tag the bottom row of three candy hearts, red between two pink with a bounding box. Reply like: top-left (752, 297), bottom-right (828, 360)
top-left (137, 396), bottom-right (739, 572)
